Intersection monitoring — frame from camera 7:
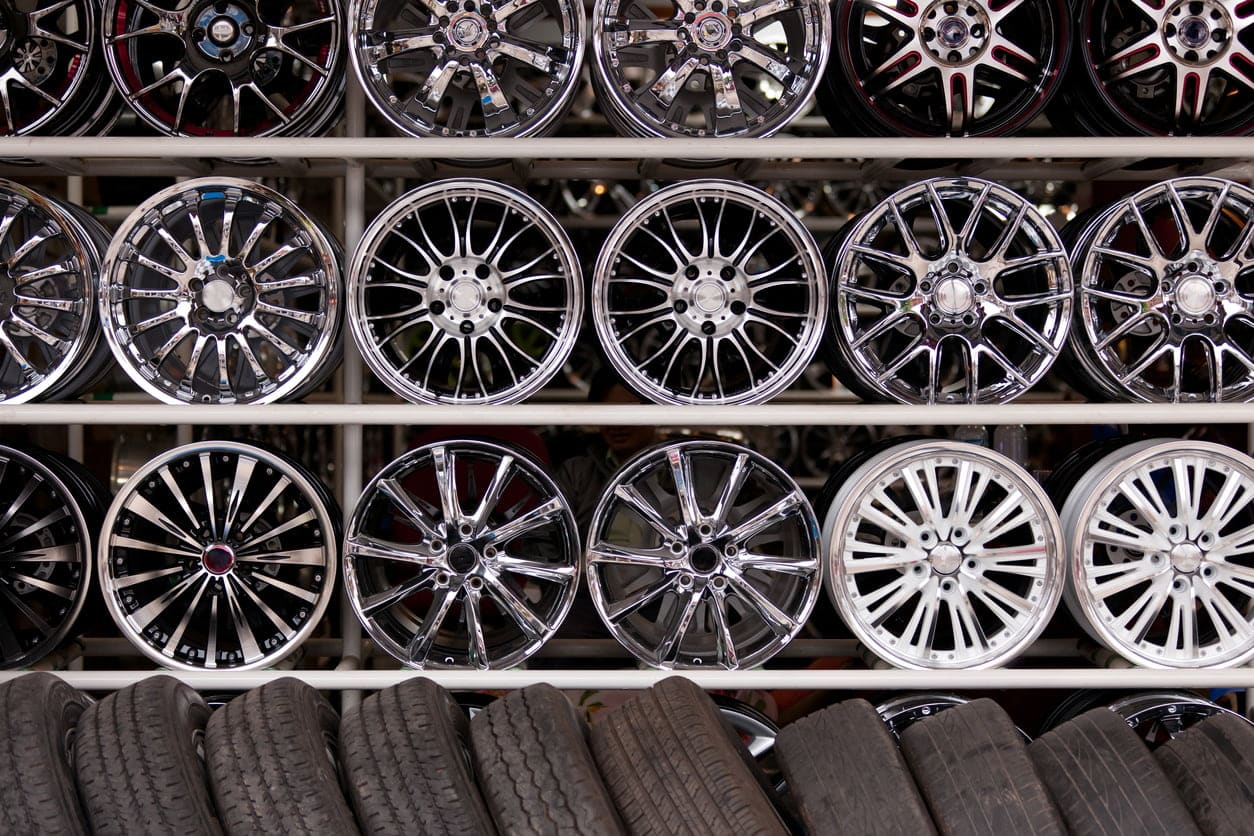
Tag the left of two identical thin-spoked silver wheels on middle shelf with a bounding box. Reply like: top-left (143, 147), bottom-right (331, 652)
top-left (349, 178), bottom-right (583, 404)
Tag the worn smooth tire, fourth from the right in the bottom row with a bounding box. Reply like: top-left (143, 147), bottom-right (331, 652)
top-left (775, 699), bottom-right (935, 836)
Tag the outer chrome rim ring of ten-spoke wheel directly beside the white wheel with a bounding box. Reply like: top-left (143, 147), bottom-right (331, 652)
top-left (583, 439), bottom-right (825, 671)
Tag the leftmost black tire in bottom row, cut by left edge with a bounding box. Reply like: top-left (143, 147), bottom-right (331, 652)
top-left (0, 673), bottom-right (92, 836)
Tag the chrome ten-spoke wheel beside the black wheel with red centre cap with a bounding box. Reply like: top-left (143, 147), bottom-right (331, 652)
top-left (344, 440), bottom-right (579, 669)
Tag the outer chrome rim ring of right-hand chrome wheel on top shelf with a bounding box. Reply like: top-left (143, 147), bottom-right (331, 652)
top-left (591, 0), bottom-right (831, 139)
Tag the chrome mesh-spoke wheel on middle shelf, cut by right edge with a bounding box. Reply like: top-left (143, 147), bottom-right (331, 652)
top-left (1070, 177), bottom-right (1254, 401)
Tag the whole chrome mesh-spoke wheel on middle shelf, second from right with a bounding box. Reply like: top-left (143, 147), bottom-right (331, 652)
top-left (826, 179), bottom-right (1072, 404)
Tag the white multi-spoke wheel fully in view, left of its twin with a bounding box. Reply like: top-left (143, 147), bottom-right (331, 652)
top-left (823, 440), bottom-right (1066, 669)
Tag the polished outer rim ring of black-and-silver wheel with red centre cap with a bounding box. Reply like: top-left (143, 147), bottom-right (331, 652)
top-left (97, 441), bottom-right (340, 673)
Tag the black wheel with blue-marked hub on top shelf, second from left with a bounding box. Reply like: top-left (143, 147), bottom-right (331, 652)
top-left (104, 0), bottom-right (345, 137)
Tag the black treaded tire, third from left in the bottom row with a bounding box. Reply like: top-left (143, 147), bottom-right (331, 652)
top-left (204, 678), bottom-right (357, 836)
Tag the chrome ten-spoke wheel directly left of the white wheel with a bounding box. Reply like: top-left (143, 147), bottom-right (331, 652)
top-left (587, 441), bottom-right (820, 669)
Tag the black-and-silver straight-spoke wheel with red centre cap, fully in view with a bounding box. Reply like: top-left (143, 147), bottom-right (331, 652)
top-left (99, 441), bottom-right (339, 671)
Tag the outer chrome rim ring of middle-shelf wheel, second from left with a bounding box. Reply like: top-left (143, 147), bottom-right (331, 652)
top-left (97, 177), bottom-right (344, 406)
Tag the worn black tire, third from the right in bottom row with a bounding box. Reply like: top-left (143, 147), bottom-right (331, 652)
top-left (902, 699), bottom-right (1066, 836)
